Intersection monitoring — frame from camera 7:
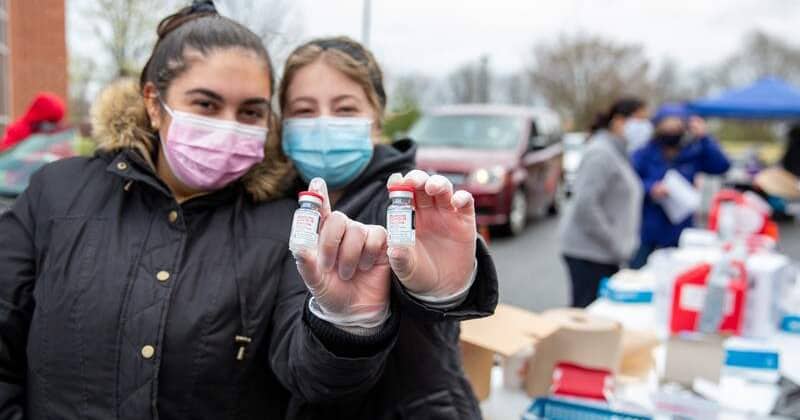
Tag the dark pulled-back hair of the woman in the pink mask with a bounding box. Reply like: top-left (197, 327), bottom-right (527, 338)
top-left (139, 0), bottom-right (275, 98)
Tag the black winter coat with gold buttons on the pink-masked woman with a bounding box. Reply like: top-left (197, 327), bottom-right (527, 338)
top-left (0, 150), bottom-right (400, 420)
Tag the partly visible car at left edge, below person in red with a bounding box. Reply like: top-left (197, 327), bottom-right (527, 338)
top-left (0, 129), bottom-right (80, 207)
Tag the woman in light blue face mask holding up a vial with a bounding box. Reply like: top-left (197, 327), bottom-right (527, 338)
top-left (280, 37), bottom-right (497, 419)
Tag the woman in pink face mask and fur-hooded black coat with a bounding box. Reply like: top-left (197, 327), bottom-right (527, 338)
top-left (0, 1), bottom-right (399, 420)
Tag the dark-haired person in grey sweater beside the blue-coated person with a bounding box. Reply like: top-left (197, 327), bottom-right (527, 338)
top-left (561, 98), bottom-right (646, 308)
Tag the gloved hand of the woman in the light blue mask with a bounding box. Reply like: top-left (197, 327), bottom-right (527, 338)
top-left (388, 169), bottom-right (478, 299)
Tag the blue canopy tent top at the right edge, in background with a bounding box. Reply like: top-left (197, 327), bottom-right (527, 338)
top-left (687, 78), bottom-right (800, 120)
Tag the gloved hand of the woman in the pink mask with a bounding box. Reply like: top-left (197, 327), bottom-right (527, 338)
top-left (295, 178), bottom-right (391, 329)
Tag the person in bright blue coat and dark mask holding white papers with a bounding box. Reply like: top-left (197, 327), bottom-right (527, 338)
top-left (630, 104), bottom-right (731, 268)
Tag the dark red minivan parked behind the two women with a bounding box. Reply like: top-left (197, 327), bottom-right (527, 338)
top-left (409, 105), bottom-right (562, 235)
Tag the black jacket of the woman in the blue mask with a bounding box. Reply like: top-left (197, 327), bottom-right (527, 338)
top-left (287, 140), bottom-right (498, 420)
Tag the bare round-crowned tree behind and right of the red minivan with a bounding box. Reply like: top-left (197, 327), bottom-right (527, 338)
top-left (528, 35), bottom-right (649, 131)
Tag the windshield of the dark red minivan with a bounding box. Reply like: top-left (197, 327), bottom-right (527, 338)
top-left (409, 115), bottom-right (522, 150)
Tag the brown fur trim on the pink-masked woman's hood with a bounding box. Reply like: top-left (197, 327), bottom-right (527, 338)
top-left (91, 79), bottom-right (295, 201)
